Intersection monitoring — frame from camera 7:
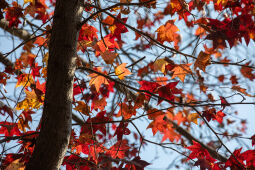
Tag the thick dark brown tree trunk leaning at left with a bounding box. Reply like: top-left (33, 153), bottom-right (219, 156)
top-left (26, 0), bottom-right (82, 170)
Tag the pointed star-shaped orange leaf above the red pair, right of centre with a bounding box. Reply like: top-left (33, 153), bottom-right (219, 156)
top-left (172, 63), bottom-right (192, 82)
